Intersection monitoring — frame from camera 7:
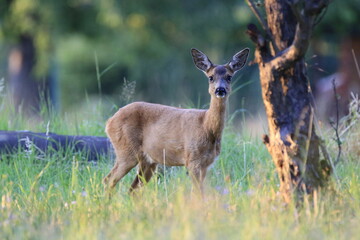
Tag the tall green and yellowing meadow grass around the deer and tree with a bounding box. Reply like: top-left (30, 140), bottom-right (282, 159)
top-left (0, 95), bottom-right (360, 240)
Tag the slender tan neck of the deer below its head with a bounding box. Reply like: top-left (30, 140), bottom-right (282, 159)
top-left (204, 97), bottom-right (226, 139)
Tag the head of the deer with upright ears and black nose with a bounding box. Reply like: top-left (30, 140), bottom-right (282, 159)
top-left (191, 48), bottom-right (250, 99)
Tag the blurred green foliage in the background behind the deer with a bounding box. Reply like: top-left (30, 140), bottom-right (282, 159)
top-left (0, 0), bottom-right (360, 111)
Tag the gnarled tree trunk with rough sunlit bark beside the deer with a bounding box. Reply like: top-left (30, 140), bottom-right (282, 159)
top-left (247, 0), bottom-right (331, 203)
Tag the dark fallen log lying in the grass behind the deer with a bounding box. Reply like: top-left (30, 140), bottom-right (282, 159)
top-left (0, 131), bottom-right (112, 161)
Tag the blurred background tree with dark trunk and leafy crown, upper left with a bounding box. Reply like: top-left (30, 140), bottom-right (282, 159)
top-left (0, 0), bottom-right (126, 114)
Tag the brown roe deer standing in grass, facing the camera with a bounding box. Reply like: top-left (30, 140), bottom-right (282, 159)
top-left (103, 48), bottom-right (249, 195)
